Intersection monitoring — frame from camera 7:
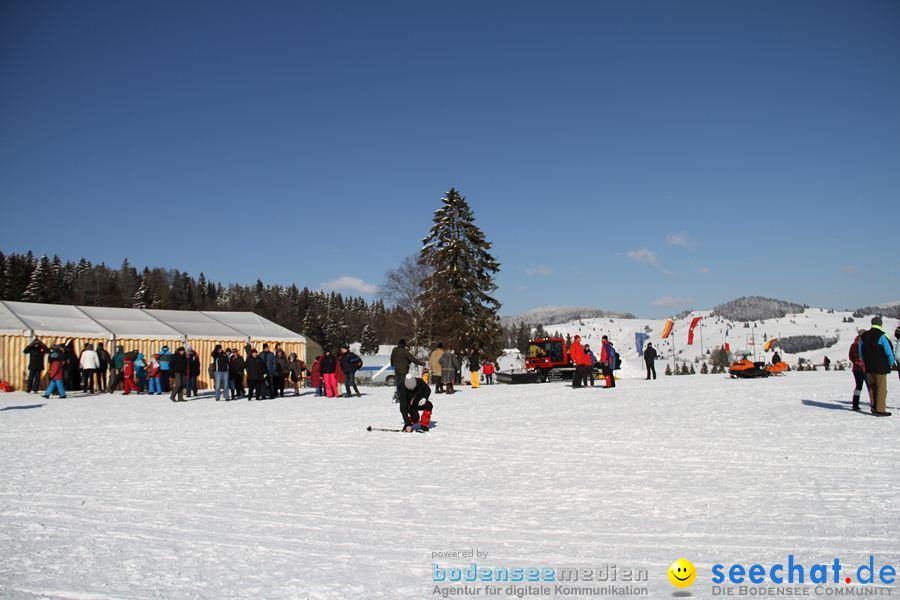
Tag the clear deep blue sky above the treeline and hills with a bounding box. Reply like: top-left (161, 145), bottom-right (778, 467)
top-left (0, 0), bottom-right (900, 316)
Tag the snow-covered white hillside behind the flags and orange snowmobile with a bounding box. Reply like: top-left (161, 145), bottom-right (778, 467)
top-left (544, 308), bottom-right (898, 377)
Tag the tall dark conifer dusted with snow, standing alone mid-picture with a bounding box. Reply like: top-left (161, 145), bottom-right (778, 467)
top-left (419, 188), bottom-right (502, 354)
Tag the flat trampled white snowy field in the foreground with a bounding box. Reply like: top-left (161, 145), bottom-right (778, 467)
top-left (0, 372), bottom-right (900, 600)
